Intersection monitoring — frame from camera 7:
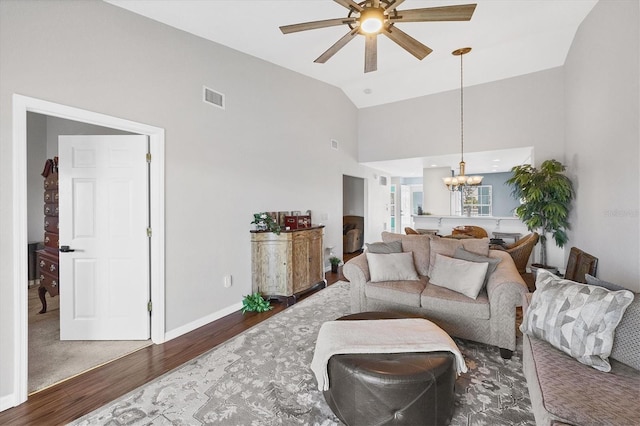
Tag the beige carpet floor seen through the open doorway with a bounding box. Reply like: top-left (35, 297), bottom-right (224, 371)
top-left (28, 287), bottom-right (151, 393)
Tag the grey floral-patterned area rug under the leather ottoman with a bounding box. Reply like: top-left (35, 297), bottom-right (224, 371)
top-left (72, 282), bottom-right (535, 426)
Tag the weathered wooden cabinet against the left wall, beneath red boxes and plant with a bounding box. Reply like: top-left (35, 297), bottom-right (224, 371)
top-left (251, 226), bottom-right (326, 305)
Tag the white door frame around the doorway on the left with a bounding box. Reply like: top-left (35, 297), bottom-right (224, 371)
top-left (11, 94), bottom-right (166, 404)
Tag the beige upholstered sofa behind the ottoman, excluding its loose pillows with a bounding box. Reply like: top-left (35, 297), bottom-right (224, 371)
top-left (343, 232), bottom-right (528, 358)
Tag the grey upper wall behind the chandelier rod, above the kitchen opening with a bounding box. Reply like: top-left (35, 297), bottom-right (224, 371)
top-left (358, 67), bottom-right (564, 165)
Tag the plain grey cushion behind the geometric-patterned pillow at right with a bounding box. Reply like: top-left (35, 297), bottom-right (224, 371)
top-left (586, 274), bottom-right (640, 370)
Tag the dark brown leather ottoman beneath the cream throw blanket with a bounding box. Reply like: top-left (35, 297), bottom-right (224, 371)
top-left (324, 312), bottom-right (456, 426)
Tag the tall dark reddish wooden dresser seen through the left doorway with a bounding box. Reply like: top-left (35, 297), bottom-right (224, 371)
top-left (36, 160), bottom-right (60, 314)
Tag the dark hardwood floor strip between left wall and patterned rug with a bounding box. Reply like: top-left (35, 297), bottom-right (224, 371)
top-left (0, 268), bottom-right (344, 426)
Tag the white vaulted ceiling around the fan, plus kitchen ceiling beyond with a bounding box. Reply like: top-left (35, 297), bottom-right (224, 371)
top-left (104, 0), bottom-right (597, 176)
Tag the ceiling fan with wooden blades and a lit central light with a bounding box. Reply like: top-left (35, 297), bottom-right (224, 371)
top-left (280, 0), bottom-right (476, 73)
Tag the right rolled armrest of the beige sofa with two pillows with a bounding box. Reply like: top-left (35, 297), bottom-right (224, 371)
top-left (487, 250), bottom-right (529, 351)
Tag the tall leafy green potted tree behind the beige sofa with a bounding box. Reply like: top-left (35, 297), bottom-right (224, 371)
top-left (506, 160), bottom-right (574, 269)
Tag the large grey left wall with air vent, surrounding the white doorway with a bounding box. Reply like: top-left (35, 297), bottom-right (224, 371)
top-left (0, 0), bottom-right (382, 405)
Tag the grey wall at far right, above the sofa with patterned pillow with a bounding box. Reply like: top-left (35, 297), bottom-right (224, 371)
top-left (564, 1), bottom-right (640, 292)
